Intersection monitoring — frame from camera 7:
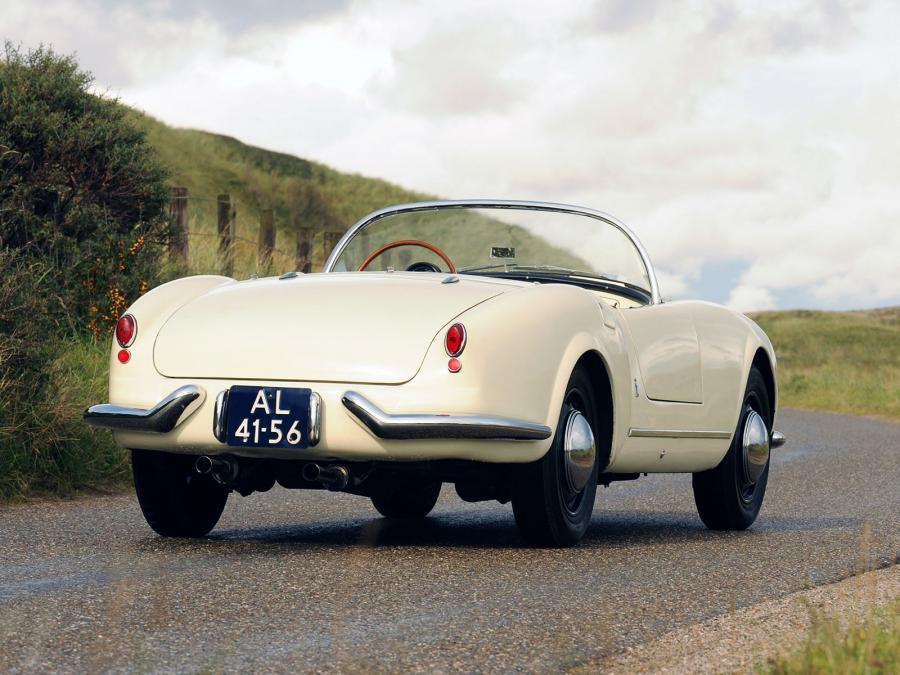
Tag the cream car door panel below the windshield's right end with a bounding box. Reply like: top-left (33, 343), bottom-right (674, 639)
top-left (621, 302), bottom-right (703, 403)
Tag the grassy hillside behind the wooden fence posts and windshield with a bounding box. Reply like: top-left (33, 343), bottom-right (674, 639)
top-left (132, 111), bottom-right (589, 277)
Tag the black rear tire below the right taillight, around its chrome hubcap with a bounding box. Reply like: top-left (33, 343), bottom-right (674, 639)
top-left (512, 368), bottom-right (600, 547)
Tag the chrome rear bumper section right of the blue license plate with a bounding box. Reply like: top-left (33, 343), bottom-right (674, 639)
top-left (341, 391), bottom-right (552, 441)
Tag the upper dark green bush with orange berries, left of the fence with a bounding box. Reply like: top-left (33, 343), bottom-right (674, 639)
top-left (0, 43), bottom-right (168, 336)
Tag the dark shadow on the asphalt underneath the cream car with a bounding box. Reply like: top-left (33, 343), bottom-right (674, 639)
top-left (146, 509), bottom-right (856, 555)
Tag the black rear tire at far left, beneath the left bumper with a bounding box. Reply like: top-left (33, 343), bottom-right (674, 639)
top-left (131, 450), bottom-right (228, 537)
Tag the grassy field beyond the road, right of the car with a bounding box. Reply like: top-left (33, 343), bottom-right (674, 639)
top-left (753, 307), bottom-right (900, 420)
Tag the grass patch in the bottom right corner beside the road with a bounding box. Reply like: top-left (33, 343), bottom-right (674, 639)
top-left (760, 602), bottom-right (900, 675)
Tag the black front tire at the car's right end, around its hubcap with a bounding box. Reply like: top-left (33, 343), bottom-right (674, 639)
top-left (692, 366), bottom-right (772, 530)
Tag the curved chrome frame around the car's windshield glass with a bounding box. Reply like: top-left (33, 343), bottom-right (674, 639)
top-left (322, 199), bottom-right (660, 305)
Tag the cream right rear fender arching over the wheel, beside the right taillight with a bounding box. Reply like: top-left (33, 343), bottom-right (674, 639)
top-left (406, 284), bottom-right (630, 460)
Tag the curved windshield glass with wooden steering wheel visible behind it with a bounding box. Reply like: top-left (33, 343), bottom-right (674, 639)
top-left (330, 205), bottom-right (652, 298)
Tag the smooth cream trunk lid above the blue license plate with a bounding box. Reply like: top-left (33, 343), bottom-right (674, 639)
top-left (153, 272), bottom-right (515, 384)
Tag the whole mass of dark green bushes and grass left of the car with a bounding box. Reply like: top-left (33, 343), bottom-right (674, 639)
top-left (0, 44), bottom-right (168, 499)
